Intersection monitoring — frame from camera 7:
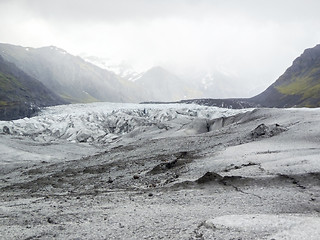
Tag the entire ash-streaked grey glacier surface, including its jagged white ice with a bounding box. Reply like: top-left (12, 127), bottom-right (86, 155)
top-left (0, 103), bottom-right (320, 240)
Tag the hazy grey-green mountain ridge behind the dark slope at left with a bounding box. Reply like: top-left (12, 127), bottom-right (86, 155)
top-left (0, 44), bottom-right (142, 103)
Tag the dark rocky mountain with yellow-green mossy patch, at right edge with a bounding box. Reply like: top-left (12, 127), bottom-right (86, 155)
top-left (250, 44), bottom-right (320, 108)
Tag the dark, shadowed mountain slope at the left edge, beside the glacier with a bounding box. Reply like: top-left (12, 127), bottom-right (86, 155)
top-left (0, 56), bottom-right (67, 120)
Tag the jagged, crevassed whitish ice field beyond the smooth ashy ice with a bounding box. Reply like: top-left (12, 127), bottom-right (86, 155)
top-left (0, 103), bottom-right (248, 144)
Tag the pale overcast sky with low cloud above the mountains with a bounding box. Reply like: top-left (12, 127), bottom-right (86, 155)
top-left (0, 0), bottom-right (320, 97)
